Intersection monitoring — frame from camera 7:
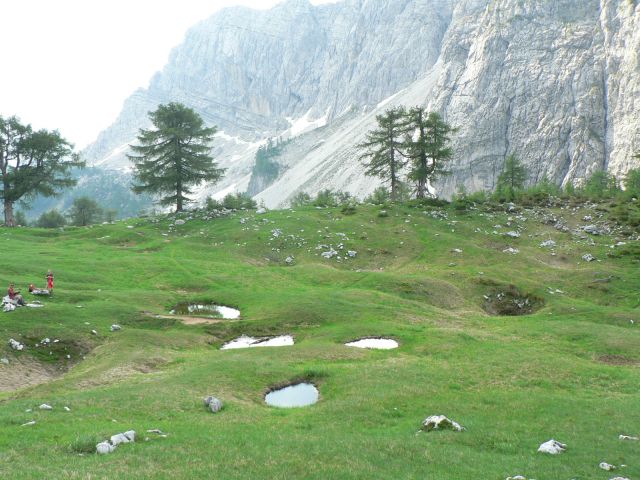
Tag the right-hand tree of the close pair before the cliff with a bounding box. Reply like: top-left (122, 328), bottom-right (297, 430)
top-left (405, 107), bottom-right (455, 199)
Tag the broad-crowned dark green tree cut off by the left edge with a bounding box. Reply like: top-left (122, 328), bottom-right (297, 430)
top-left (0, 116), bottom-right (84, 227)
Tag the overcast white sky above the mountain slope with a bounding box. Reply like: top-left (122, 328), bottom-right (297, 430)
top-left (0, 0), bottom-right (336, 148)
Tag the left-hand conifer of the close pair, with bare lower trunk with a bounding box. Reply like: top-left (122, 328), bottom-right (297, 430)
top-left (357, 107), bottom-right (408, 202)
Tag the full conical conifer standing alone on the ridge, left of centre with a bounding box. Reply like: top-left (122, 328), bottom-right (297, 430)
top-left (129, 103), bottom-right (224, 212)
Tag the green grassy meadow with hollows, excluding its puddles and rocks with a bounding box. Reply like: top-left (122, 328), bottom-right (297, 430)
top-left (0, 201), bottom-right (640, 480)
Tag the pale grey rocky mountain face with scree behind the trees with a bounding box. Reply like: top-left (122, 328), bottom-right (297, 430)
top-left (84, 0), bottom-right (640, 207)
